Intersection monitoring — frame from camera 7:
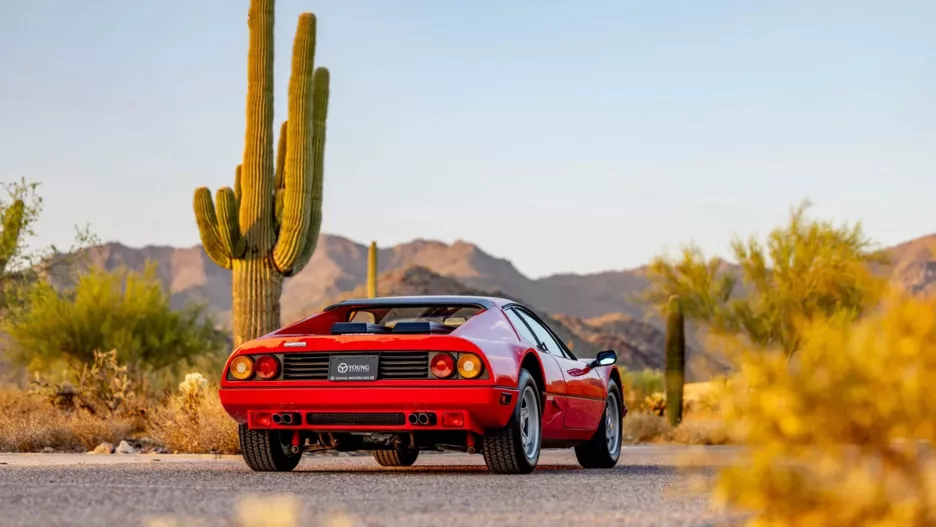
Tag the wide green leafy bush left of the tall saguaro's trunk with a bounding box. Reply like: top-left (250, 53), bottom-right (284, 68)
top-left (0, 262), bottom-right (224, 370)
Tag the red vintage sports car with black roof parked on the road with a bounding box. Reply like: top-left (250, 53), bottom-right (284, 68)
top-left (220, 296), bottom-right (627, 474)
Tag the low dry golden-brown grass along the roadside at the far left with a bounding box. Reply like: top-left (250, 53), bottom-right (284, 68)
top-left (0, 390), bottom-right (135, 452)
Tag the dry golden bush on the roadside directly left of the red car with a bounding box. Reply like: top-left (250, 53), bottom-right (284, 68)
top-left (147, 373), bottom-right (240, 454)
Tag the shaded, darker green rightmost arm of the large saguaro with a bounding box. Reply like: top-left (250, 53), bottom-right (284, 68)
top-left (287, 68), bottom-right (329, 276)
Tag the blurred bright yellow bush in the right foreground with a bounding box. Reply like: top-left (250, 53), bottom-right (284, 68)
top-left (716, 298), bottom-right (936, 527)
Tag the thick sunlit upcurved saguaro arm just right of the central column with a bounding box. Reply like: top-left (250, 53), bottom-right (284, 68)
top-left (273, 13), bottom-right (315, 271)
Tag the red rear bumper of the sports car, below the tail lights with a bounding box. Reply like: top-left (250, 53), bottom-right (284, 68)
top-left (219, 386), bottom-right (517, 434)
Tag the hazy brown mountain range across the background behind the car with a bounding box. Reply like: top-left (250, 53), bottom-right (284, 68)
top-left (75, 234), bottom-right (936, 378)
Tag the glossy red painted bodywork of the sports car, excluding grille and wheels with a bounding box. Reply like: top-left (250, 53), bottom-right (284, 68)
top-left (219, 298), bottom-right (612, 441)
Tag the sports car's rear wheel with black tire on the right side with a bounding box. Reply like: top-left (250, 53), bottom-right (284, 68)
top-left (481, 369), bottom-right (543, 474)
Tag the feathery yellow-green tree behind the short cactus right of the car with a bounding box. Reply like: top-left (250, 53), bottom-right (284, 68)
top-left (643, 202), bottom-right (886, 355)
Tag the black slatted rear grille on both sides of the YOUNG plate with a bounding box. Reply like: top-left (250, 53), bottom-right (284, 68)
top-left (283, 351), bottom-right (429, 381)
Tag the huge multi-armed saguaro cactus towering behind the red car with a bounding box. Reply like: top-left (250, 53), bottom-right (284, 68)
top-left (195, 0), bottom-right (329, 346)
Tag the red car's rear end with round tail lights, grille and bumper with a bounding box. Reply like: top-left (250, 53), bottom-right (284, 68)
top-left (220, 305), bottom-right (516, 451)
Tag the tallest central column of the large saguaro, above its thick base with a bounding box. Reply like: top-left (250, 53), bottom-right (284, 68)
top-left (239, 0), bottom-right (274, 254)
